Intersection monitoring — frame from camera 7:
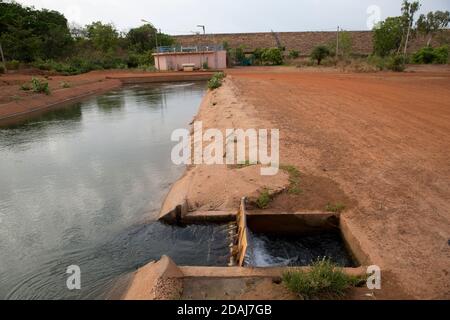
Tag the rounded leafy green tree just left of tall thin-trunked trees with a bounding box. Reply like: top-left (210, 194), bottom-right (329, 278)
top-left (373, 17), bottom-right (403, 57)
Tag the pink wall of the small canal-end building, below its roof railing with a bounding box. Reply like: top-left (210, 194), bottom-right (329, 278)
top-left (155, 51), bottom-right (227, 71)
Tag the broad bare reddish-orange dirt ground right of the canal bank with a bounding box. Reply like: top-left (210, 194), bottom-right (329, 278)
top-left (225, 66), bottom-right (450, 299)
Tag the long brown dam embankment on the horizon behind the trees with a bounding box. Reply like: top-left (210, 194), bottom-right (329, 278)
top-left (174, 30), bottom-right (450, 55)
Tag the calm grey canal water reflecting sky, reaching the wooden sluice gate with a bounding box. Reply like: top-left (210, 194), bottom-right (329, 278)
top-left (0, 82), bottom-right (228, 299)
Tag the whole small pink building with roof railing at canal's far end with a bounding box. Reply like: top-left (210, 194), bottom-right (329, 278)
top-left (153, 46), bottom-right (227, 71)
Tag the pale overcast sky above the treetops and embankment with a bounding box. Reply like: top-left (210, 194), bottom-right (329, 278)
top-left (17, 0), bottom-right (450, 34)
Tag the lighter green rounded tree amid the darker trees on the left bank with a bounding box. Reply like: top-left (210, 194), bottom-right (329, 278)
top-left (86, 21), bottom-right (119, 53)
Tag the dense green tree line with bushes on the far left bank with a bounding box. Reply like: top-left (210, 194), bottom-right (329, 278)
top-left (0, 0), bottom-right (174, 73)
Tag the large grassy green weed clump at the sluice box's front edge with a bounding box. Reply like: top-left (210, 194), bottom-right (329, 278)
top-left (283, 258), bottom-right (362, 299)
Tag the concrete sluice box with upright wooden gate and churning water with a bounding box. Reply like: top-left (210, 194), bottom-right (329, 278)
top-left (123, 199), bottom-right (366, 300)
